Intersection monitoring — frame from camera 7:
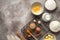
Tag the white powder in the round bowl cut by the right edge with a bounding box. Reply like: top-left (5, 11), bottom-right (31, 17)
top-left (49, 21), bottom-right (60, 32)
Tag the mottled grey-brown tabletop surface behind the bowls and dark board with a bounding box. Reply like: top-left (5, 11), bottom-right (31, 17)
top-left (0, 0), bottom-right (60, 40)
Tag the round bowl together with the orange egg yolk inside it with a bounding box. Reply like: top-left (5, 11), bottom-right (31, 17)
top-left (31, 2), bottom-right (43, 15)
